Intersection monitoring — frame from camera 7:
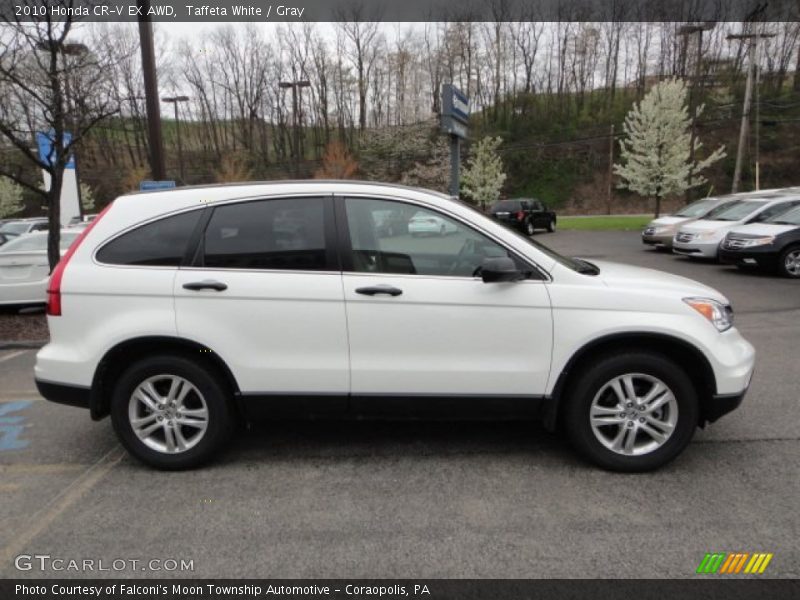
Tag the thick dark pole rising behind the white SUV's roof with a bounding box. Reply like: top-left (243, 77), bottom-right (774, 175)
top-left (136, 0), bottom-right (166, 181)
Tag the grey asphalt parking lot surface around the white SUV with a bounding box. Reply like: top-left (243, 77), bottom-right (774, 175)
top-left (0, 232), bottom-right (800, 578)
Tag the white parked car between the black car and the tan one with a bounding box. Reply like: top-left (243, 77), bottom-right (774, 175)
top-left (672, 189), bottom-right (800, 260)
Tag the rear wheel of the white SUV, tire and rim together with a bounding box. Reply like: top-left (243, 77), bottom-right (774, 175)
top-left (111, 355), bottom-right (233, 470)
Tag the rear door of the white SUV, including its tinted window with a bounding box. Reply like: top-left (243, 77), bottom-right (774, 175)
top-left (175, 198), bottom-right (349, 394)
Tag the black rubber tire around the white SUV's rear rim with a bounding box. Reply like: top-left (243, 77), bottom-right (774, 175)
top-left (111, 355), bottom-right (235, 471)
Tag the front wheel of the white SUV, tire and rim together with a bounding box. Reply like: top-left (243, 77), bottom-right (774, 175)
top-left (564, 352), bottom-right (698, 472)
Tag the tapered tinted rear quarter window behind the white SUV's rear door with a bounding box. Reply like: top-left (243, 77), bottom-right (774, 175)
top-left (97, 209), bottom-right (203, 267)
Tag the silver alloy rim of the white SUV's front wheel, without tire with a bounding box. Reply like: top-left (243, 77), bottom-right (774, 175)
top-left (589, 373), bottom-right (678, 456)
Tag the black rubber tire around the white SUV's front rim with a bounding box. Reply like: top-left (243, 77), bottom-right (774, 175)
top-left (564, 351), bottom-right (699, 473)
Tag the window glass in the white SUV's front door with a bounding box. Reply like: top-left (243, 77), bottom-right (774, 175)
top-left (345, 198), bottom-right (531, 277)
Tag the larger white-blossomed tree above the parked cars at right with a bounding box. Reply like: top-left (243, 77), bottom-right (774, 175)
top-left (614, 79), bottom-right (725, 217)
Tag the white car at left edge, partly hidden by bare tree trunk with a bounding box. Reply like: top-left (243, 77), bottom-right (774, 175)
top-left (0, 230), bottom-right (81, 305)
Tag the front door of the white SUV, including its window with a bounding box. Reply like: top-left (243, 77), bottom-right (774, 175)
top-left (337, 198), bottom-right (552, 396)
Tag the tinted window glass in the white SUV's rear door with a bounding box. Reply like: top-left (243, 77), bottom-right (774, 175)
top-left (203, 198), bottom-right (329, 271)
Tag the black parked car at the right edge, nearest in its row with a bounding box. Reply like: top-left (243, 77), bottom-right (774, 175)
top-left (719, 206), bottom-right (800, 279)
